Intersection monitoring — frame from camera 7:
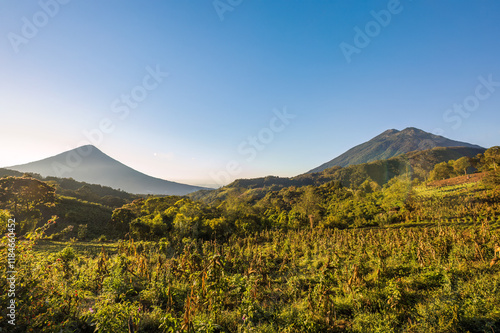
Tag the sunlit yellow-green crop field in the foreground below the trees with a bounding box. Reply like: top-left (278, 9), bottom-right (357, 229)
top-left (0, 221), bottom-right (500, 332)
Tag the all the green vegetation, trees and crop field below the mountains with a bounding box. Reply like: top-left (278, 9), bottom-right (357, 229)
top-left (0, 147), bottom-right (500, 332)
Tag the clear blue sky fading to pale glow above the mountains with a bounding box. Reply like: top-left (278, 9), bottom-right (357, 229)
top-left (0, 0), bottom-right (500, 186)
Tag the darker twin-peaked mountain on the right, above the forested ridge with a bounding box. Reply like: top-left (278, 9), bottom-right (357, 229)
top-left (307, 127), bottom-right (482, 173)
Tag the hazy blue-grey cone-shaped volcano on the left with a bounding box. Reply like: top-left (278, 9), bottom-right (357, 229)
top-left (6, 145), bottom-right (204, 195)
